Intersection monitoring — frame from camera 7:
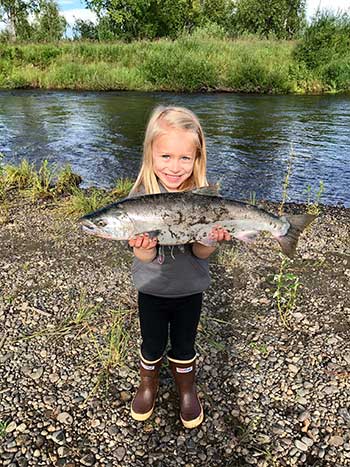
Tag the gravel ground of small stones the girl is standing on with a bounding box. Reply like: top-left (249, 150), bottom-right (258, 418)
top-left (0, 199), bottom-right (350, 467)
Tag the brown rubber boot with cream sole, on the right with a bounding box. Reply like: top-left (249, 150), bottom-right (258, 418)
top-left (168, 357), bottom-right (204, 428)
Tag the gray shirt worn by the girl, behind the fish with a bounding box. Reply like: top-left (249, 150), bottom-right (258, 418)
top-left (129, 184), bottom-right (210, 297)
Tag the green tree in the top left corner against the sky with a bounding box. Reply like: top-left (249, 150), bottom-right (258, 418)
top-left (0, 0), bottom-right (39, 40)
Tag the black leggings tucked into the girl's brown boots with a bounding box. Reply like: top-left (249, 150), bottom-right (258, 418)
top-left (138, 292), bottom-right (203, 361)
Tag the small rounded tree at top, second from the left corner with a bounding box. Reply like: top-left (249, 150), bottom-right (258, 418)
top-left (33, 0), bottom-right (67, 42)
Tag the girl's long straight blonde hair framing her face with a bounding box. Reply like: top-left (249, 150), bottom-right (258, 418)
top-left (130, 106), bottom-right (208, 194)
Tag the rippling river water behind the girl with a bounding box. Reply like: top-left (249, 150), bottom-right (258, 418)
top-left (0, 91), bottom-right (350, 207)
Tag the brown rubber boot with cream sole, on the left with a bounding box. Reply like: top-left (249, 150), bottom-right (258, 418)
top-left (131, 356), bottom-right (162, 421)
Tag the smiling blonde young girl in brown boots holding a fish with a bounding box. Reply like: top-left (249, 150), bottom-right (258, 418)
top-left (129, 107), bottom-right (230, 428)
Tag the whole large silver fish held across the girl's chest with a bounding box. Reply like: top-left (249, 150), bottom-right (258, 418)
top-left (79, 187), bottom-right (317, 258)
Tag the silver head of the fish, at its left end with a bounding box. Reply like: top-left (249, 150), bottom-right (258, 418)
top-left (79, 206), bottom-right (134, 240)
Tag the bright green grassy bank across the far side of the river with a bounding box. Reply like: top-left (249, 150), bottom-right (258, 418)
top-left (0, 35), bottom-right (350, 94)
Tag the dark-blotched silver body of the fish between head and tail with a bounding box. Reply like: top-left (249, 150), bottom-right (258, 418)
top-left (117, 192), bottom-right (289, 245)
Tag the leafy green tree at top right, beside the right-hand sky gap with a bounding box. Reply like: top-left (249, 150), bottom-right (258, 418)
top-left (233, 0), bottom-right (305, 39)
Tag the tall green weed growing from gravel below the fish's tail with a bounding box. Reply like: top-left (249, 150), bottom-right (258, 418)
top-left (273, 257), bottom-right (300, 329)
